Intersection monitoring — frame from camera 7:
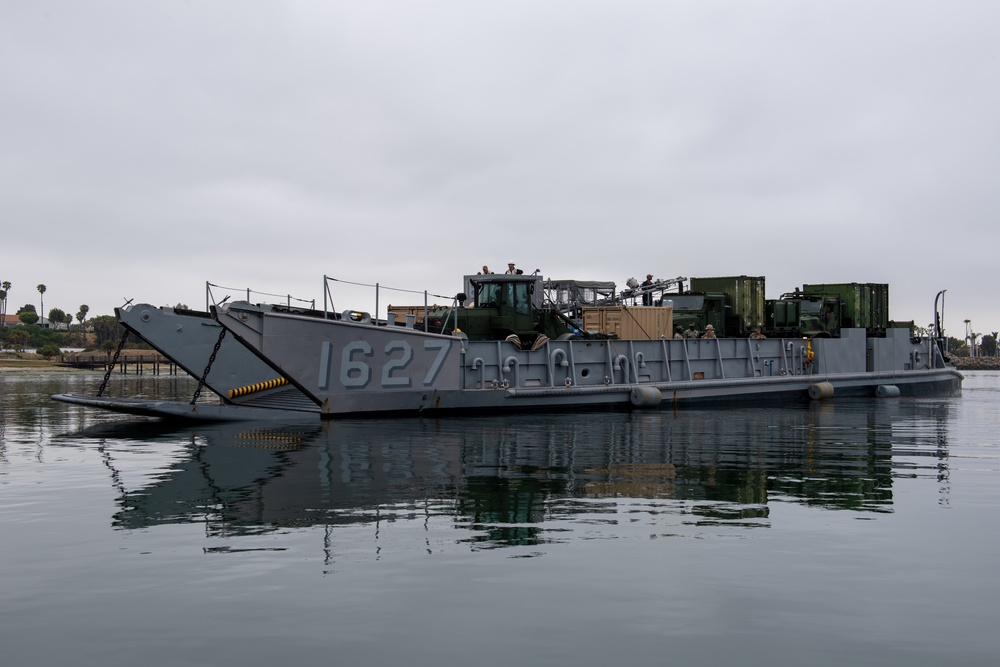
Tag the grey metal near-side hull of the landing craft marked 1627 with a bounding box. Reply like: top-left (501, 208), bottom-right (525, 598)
top-left (213, 302), bottom-right (962, 417)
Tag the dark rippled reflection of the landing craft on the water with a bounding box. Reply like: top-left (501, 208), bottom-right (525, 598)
top-left (101, 401), bottom-right (948, 546)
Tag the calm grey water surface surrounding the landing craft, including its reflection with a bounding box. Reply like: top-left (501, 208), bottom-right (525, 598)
top-left (0, 373), bottom-right (1000, 667)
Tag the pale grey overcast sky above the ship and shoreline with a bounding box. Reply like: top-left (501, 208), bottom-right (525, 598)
top-left (0, 0), bottom-right (1000, 337)
